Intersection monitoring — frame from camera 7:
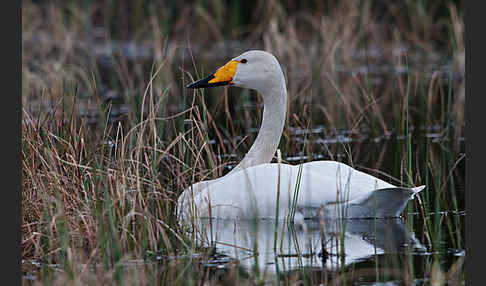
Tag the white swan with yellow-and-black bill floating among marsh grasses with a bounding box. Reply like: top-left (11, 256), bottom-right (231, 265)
top-left (178, 50), bottom-right (425, 219)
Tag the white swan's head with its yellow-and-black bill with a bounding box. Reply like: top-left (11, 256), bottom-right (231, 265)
top-left (187, 50), bottom-right (284, 93)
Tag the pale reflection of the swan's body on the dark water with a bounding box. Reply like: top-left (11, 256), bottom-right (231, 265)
top-left (199, 218), bottom-right (424, 273)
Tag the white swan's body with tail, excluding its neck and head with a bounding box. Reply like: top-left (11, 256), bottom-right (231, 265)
top-left (180, 161), bottom-right (423, 220)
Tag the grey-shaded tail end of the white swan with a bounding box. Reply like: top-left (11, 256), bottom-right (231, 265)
top-left (330, 186), bottom-right (425, 218)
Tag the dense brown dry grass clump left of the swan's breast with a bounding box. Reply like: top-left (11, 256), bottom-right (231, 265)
top-left (22, 72), bottom-right (226, 262)
